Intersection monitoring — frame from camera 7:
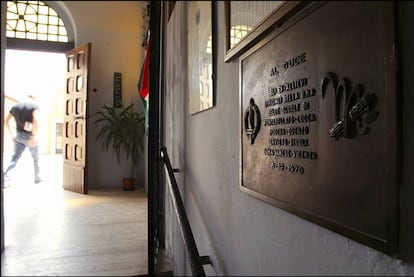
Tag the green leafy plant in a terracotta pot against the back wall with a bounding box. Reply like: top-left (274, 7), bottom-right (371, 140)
top-left (94, 103), bottom-right (144, 190)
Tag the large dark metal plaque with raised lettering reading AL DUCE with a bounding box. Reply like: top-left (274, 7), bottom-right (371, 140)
top-left (240, 2), bottom-right (398, 253)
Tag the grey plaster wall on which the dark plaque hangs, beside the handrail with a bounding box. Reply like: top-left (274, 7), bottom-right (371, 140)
top-left (165, 2), bottom-right (414, 276)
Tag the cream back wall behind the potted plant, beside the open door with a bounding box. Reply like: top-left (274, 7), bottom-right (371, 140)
top-left (64, 1), bottom-right (145, 188)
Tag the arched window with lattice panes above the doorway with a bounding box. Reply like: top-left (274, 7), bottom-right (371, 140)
top-left (6, 1), bottom-right (68, 42)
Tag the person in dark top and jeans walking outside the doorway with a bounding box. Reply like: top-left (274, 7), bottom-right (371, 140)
top-left (4, 95), bottom-right (42, 186)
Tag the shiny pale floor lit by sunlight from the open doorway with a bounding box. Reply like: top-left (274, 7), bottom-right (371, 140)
top-left (1, 154), bottom-right (148, 276)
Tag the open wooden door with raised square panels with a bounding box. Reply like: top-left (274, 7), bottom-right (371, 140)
top-left (63, 43), bottom-right (91, 194)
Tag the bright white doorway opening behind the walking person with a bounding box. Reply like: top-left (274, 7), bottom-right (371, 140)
top-left (2, 49), bottom-right (66, 188)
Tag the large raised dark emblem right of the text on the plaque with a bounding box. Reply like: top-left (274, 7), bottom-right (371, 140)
top-left (321, 72), bottom-right (379, 140)
